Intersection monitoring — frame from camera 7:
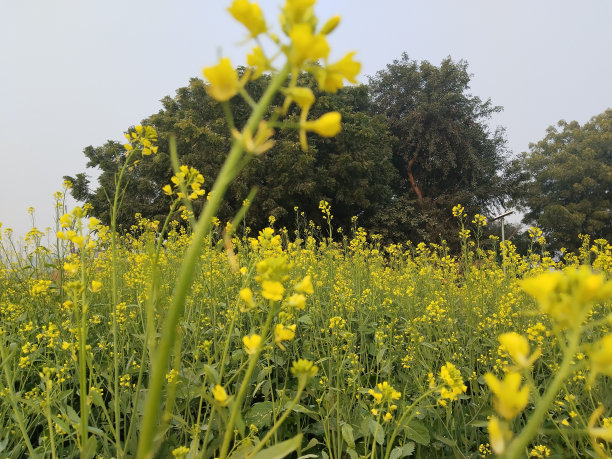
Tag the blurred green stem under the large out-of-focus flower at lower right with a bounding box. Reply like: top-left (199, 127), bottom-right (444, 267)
top-left (504, 328), bottom-right (581, 459)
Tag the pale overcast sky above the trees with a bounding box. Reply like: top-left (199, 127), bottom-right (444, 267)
top-left (0, 0), bottom-right (612, 234)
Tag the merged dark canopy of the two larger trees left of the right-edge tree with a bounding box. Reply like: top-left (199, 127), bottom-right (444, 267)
top-left (66, 54), bottom-right (508, 241)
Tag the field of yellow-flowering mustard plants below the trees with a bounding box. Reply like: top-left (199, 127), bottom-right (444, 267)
top-left (0, 199), bottom-right (612, 458)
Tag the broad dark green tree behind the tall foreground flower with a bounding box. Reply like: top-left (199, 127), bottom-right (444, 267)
top-left (66, 75), bottom-right (396, 235)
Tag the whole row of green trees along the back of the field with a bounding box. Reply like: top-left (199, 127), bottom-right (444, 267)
top-left (65, 54), bottom-right (612, 252)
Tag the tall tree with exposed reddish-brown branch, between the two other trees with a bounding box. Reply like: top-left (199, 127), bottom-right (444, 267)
top-left (369, 53), bottom-right (509, 240)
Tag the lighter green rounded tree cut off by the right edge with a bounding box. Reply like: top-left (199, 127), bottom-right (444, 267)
top-left (513, 109), bottom-right (612, 249)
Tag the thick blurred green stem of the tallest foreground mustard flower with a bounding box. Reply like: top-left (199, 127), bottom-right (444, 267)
top-left (137, 65), bottom-right (289, 458)
